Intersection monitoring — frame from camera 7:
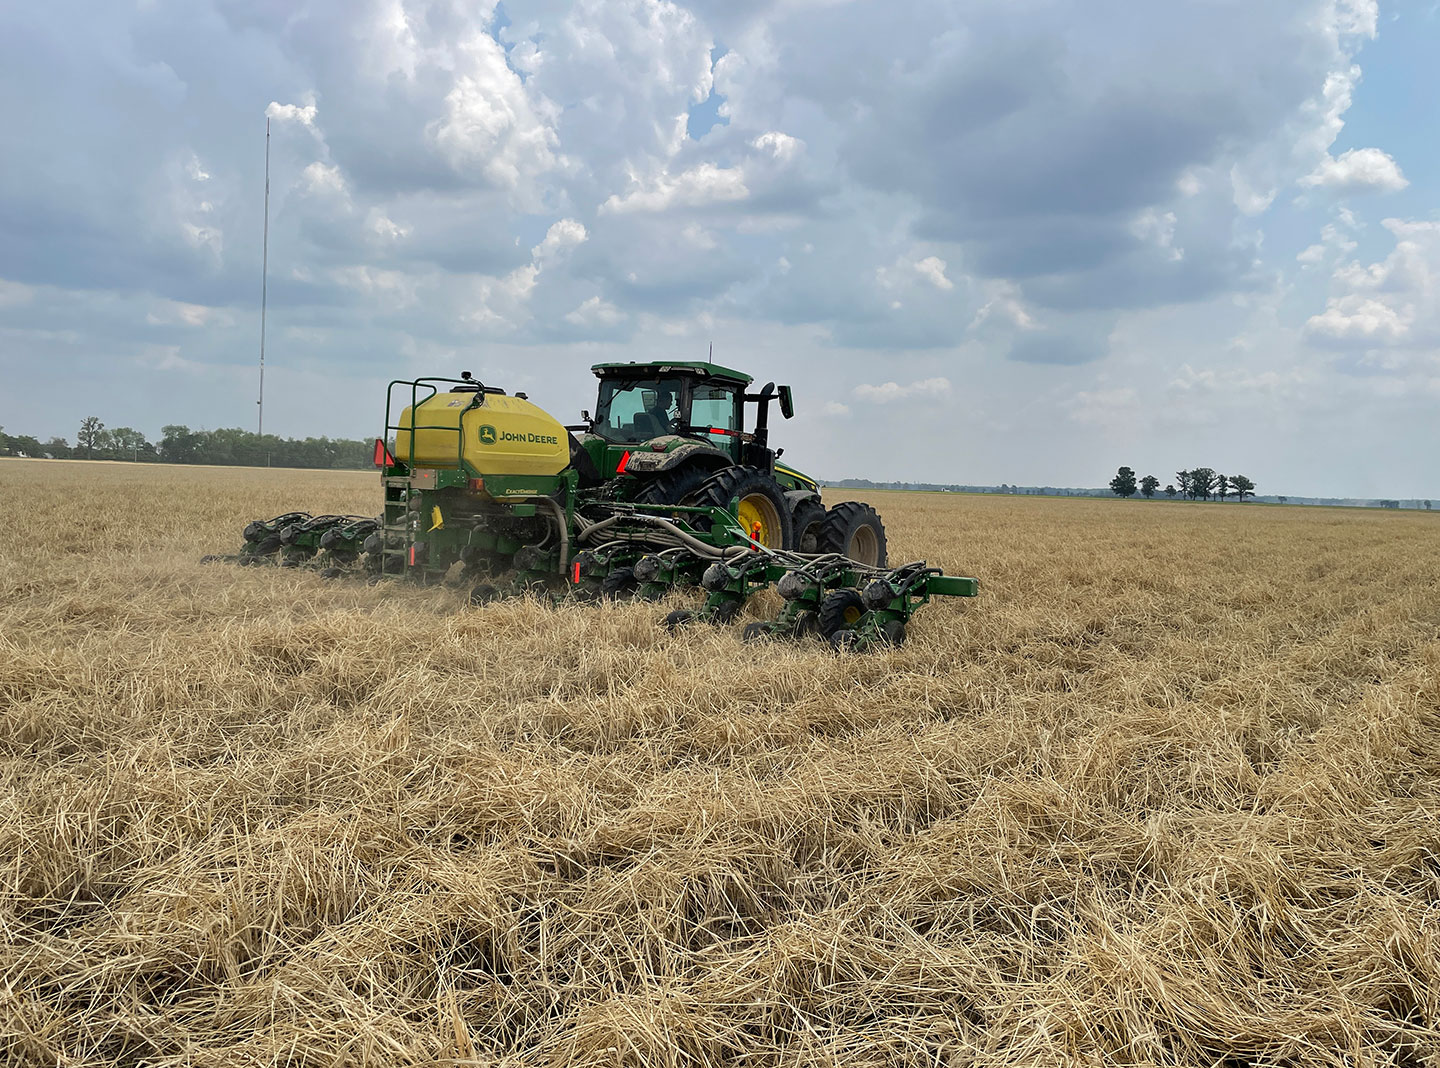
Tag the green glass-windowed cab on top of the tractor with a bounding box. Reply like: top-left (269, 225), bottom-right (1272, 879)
top-left (586, 361), bottom-right (793, 469)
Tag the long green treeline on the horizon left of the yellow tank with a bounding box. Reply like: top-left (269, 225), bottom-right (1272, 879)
top-left (0, 416), bottom-right (374, 468)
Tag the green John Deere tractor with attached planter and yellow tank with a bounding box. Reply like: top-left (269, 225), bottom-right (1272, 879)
top-left (213, 361), bottom-right (978, 646)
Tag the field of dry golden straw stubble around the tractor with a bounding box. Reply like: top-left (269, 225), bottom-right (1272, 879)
top-left (0, 461), bottom-right (1440, 1068)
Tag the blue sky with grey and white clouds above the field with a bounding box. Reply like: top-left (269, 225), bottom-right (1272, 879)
top-left (0, 0), bottom-right (1440, 498)
